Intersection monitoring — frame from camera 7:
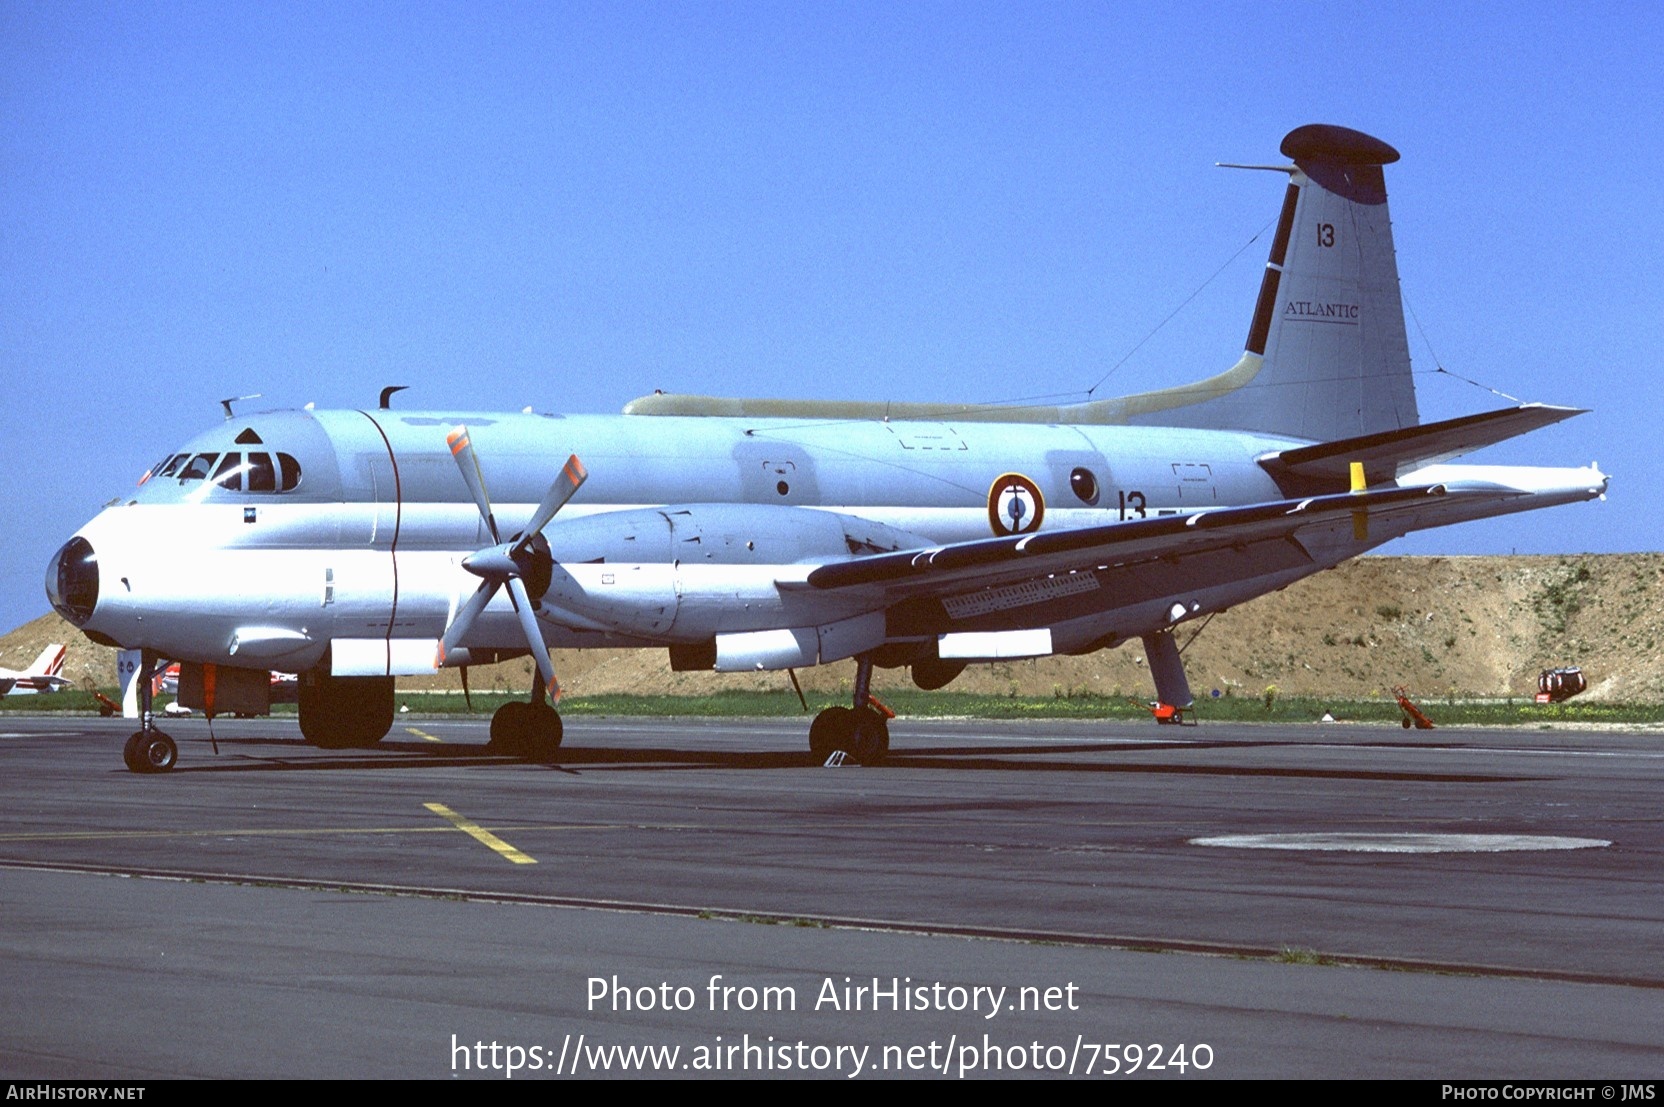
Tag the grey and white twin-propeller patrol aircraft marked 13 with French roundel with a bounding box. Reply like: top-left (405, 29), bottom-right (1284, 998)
top-left (47, 125), bottom-right (1607, 771)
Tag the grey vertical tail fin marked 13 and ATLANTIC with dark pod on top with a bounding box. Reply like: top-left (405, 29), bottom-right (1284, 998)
top-left (1140, 123), bottom-right (1419, 441)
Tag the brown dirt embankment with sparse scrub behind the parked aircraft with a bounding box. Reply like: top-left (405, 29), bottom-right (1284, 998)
top-left (13, 554), bottom-right (1664, 702)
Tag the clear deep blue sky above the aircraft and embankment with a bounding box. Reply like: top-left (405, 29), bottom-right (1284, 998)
top-left (0, 0), bottom-right (1664, 629)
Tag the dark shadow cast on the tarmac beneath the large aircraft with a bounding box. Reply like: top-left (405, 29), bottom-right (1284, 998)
top-left (116, 736), bottom-right (1538, 782)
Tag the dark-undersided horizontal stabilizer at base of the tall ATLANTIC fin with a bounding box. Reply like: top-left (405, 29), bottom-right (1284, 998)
top-left (1260, 403), bottom-right (1584, 488)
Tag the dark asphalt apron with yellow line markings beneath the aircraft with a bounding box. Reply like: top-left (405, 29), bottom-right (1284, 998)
top-left (0, 717), bottom-right (1664, 1080)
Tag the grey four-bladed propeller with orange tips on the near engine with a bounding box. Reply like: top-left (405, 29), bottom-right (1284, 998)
top-left (438, 426), bottom-right (589, 697)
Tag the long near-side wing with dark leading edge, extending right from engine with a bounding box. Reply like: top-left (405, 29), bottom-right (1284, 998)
top-left (802, 481), bottom-right (1557, 599)
